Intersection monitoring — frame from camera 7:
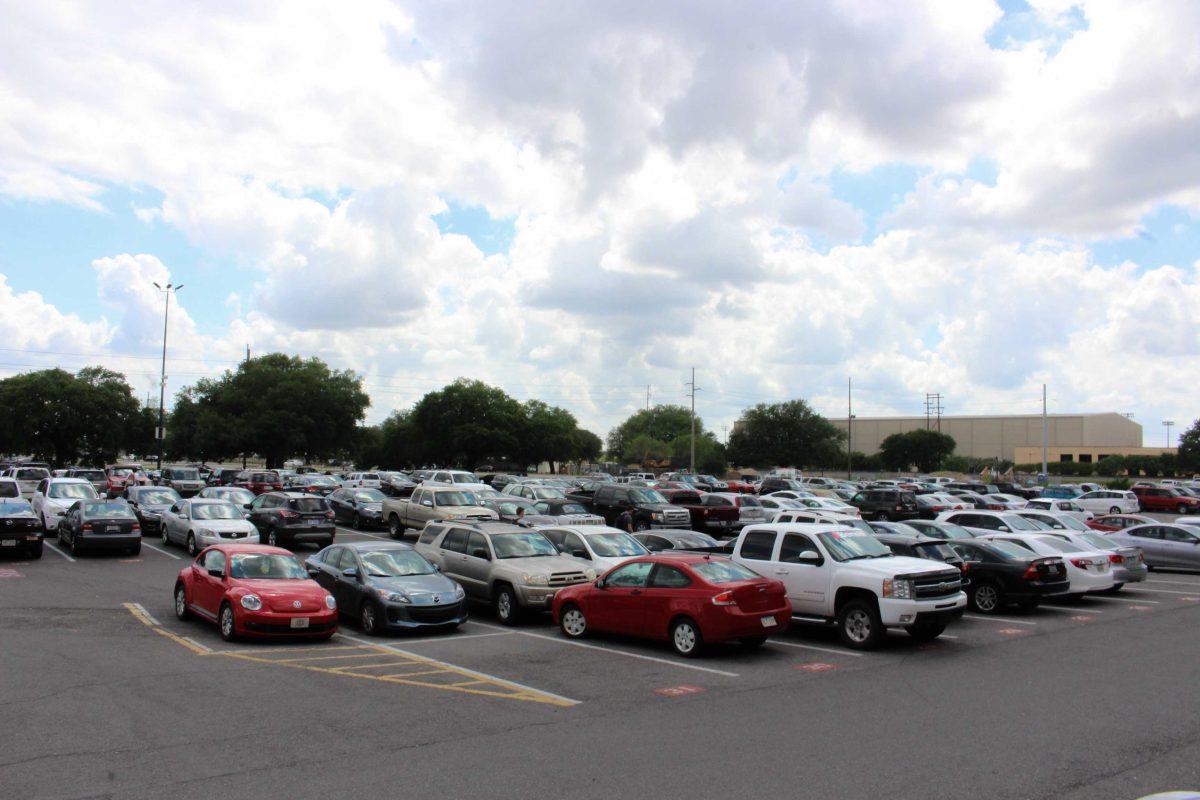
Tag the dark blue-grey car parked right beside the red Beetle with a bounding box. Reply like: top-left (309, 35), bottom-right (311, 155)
top-left (305, 542), bottom-right (467, 636)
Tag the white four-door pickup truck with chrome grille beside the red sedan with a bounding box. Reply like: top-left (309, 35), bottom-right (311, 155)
top-left (733, 523), bottom-right (967, 650)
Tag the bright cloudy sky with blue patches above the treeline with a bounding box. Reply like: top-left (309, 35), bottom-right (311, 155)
top-left (0, 0), bottom-right (1200, 446)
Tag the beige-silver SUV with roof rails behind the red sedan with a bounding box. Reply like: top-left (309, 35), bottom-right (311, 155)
top-left (416, 521), bottom-right (596, 625)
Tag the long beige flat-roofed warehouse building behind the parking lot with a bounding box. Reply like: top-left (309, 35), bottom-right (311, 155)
top-left (829, 413), bottom-right (1163, 463)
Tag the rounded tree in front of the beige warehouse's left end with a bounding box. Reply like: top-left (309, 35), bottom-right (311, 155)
top-left (728, 399), bottom-right (846, 468)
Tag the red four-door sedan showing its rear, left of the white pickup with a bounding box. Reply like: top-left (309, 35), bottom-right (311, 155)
top-left (553, 554), bottom-right (792, 657)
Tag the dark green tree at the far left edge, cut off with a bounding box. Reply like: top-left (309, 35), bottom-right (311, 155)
top-left (0, 367), bottom-right (145, 467)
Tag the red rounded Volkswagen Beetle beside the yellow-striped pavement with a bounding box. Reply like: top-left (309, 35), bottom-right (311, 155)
top-left (175, 545), bottom-right (337, 642)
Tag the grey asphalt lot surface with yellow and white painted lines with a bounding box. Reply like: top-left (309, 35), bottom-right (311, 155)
top-left (0, 520), bottom-right (1200, 798)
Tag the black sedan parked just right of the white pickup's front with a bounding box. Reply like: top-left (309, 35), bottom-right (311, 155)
top-left (949, 539), bottom-right (1070, 614)
